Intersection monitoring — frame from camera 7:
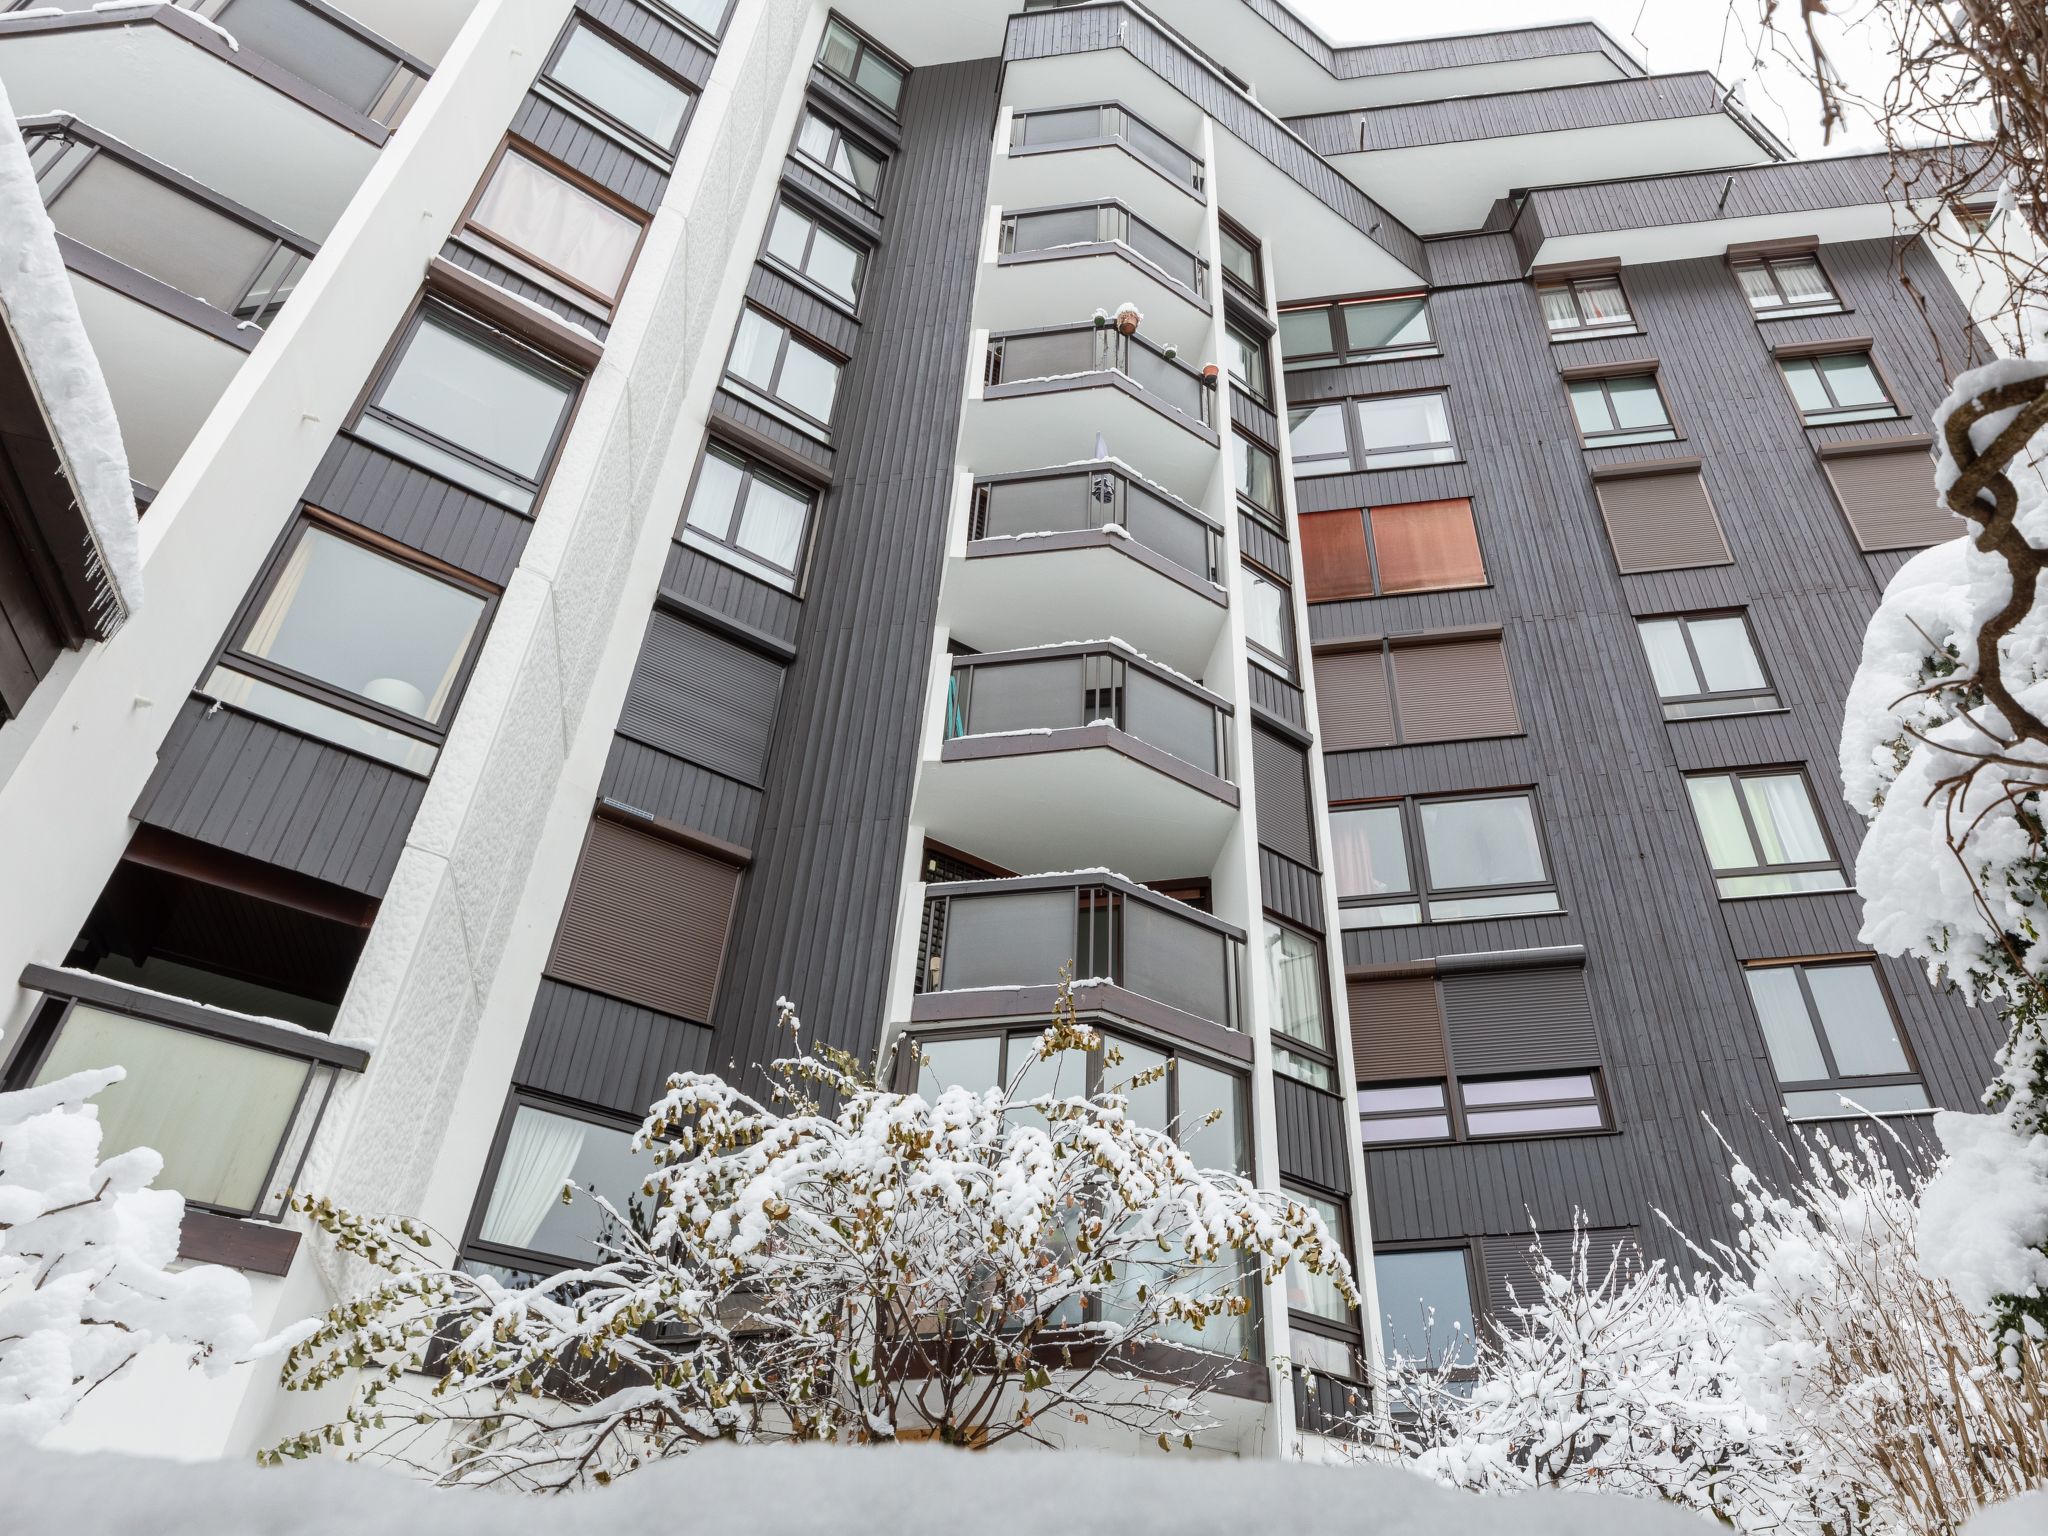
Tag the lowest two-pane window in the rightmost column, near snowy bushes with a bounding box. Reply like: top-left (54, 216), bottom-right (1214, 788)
top-left (1745, 961), bottom-right (1929, 1120)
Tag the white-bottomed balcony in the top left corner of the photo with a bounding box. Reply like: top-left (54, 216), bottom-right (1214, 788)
top-left (0, 0), bottom-right (428, 242)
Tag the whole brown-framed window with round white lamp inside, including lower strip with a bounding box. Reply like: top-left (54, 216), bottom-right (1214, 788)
top-left (205, 522), bottom-right (487, 772)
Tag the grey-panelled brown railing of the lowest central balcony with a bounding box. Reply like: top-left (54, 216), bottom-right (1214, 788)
top-left (915, 870), bottom-right (1245, 1030)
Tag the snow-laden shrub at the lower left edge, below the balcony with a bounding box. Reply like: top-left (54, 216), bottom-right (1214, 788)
top-left (0, 1067), bottom-right (289, 1440)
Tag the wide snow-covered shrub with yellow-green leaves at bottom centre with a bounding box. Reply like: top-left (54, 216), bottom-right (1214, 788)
top-left (272, 991), bottom-right (1356, 1489)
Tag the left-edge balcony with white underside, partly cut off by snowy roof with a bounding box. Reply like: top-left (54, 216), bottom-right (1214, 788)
top-left (20, 117), bottom-right (313, 485)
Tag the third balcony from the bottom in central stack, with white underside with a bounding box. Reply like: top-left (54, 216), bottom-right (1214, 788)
top-left (940, 459), bottom-right (1227, 676)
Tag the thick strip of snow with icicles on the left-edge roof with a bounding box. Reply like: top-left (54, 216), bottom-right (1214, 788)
top-left (0, 76), bottom-right (141, 635)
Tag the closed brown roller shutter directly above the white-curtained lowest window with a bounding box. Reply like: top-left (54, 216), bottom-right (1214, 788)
top-left (547, 819), bottom-right (739, 1024)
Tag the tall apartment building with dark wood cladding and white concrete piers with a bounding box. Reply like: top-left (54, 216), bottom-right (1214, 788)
top-left (0, 0), bottom-right (1999, 1454)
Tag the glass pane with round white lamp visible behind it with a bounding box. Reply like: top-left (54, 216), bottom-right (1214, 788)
top-left (242, 528), bottom-right (483, 721)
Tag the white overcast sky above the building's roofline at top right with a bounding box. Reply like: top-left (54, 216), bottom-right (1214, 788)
top-left (1286, 0), bottom-right (1894, 156)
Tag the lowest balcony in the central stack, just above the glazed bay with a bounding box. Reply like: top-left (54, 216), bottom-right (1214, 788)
top-left (911, 870), bottom-right (1249, 1057)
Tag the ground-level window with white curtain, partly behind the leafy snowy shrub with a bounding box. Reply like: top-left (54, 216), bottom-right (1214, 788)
top-left (471, 1102), bottom-right (653, 1274)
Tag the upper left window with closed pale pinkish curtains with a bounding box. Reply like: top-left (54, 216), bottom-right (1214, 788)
top-left (467, 150), bottom-right (643, 313)
